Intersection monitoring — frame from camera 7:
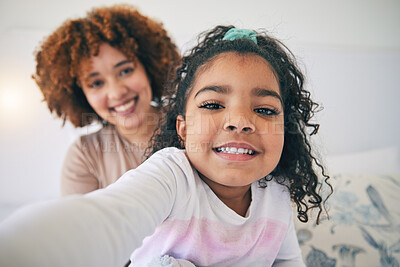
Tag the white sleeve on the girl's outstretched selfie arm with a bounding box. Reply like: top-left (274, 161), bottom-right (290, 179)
top-left (0, 151), bottom-right (183, 267)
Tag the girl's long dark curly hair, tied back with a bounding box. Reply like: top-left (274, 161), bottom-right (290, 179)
top-left (148, 26), bottom-right (333, 223)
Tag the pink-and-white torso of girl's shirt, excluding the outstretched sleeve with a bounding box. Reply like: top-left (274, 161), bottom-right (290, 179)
top-left (124, 149), bottom-right (301, 266)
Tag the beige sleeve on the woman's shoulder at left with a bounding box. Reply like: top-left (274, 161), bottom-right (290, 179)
top-left (60, 138), bottom-right (99, 196)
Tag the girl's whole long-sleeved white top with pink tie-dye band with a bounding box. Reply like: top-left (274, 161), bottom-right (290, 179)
top-left (0, 148), bottom-right (304, 267)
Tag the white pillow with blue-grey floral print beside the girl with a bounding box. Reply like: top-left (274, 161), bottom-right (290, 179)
top-left (295, 174), bottom-right (400, 267)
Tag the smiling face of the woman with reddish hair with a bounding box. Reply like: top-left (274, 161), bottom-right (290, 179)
top-left (80, 43), bottom-right (154, 134)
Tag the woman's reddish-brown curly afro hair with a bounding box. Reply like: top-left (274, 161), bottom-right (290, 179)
top-left (32, 5), bottom-right (180, 127)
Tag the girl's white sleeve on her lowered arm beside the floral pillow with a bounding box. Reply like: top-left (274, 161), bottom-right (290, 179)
top-left (272, 210), bottom-right (305, 267)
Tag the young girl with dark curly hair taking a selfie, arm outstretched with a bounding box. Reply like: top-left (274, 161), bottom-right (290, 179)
top-left (0, 26), bottom-right (328, 266)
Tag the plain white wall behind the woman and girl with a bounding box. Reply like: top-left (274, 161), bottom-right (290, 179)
top-left (0, 0), bottom-right (400, 209)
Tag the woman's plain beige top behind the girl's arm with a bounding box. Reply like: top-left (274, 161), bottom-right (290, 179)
top-left (61, 124), bottom-right (147, 196)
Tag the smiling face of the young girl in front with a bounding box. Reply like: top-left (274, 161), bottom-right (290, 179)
top-left (177, 52), bottom-right (284, 195)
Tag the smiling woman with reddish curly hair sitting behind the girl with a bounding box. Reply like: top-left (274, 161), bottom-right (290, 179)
top-left (33, 5), bottom-right (180, 195)
